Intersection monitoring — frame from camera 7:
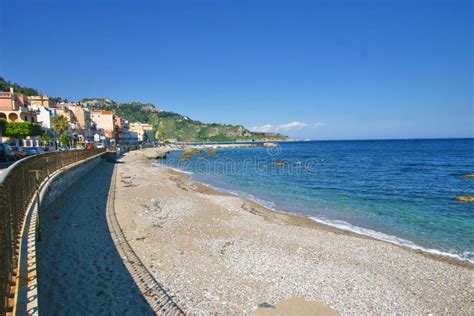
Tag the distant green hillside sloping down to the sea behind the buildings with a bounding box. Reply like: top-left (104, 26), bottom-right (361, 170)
top-left (81, 98), bottom-right (288, 142)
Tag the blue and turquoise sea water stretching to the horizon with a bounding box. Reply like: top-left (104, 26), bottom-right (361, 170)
top-left (157, 139), bottom-right (474, 262)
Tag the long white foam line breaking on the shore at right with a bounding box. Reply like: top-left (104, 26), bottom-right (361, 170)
top-left (309, 216), bottom-right (474, 263)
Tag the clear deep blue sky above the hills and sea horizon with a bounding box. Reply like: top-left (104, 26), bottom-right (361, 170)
top-left (0, 0), bottom-right (474, 139)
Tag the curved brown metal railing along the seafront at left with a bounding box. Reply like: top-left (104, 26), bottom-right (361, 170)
top-left (0, 148), bottom-right (106, 315)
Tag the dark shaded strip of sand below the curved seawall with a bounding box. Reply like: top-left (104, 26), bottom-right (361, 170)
top-left (37, 162), bottom-right (154, 315)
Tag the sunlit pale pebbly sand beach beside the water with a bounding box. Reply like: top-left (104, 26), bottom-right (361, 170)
top-left (108, 152), bottom-right (474, 315)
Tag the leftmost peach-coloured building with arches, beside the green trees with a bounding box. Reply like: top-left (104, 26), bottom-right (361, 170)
top-left (0, 88), bottom-right (36, 122)
